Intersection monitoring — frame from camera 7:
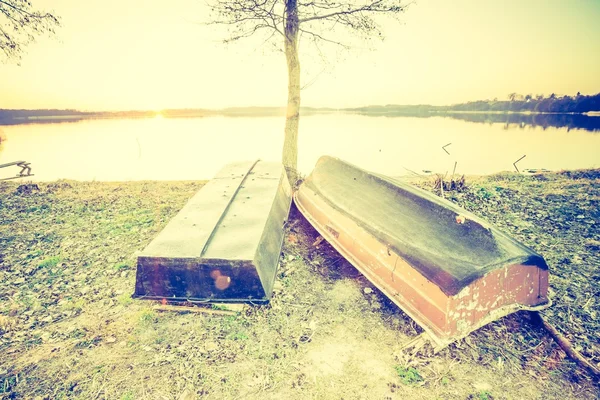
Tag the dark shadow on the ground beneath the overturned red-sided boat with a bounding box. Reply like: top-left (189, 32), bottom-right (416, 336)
top-left (283, 202), bottom-right (555, 367)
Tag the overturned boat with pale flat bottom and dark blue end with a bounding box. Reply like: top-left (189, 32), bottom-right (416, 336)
top-left (133, 161), bottom-right (291, 303)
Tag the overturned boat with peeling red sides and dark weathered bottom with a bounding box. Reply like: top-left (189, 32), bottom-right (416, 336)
top-left (294, 156), bottom-right (550, 349)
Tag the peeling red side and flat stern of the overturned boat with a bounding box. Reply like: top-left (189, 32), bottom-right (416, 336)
top-left (294, 156), bottom-right (550, 350)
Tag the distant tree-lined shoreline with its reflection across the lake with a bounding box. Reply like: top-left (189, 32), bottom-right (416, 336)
top-left (0, 93), bottom-right (600, 132)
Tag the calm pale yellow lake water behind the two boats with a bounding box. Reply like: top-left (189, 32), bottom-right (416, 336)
top-left (0, 114), bottom-right (600, 181)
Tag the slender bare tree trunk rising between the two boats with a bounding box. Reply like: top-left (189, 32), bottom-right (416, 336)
top-left (282, 0), bottom-right (300, 187)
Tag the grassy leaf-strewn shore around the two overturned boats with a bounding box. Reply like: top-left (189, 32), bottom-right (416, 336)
top-left (0, 170), bottom-right (600, 400)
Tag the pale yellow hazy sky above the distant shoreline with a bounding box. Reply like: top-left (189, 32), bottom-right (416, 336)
top-left (0, 0), bottom-right (600, 111)
